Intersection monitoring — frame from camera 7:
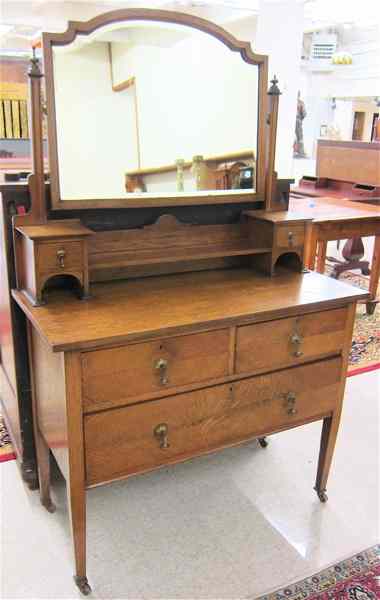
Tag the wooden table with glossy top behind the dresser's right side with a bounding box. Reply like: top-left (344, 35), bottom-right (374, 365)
top-left (289, 196), bottom-right (380, 314)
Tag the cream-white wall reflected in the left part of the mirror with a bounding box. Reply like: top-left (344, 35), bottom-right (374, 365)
top-left (54, 43), bottom-right (137, 200)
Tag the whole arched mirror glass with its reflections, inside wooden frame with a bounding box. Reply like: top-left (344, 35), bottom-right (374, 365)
top-left (53, 21), bottom-right (258, 200)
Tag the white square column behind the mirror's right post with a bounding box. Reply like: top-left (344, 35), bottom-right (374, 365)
top-left (252, 0), bottom-right (304, 178)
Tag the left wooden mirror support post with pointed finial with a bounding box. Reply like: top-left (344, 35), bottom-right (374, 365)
top-left (28, 47), bottom-right (47, 224)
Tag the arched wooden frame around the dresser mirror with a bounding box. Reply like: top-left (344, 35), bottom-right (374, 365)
top-left (42, 8), bottom-right (268, 210)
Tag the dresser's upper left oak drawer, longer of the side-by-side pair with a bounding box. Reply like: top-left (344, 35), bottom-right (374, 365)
top-left (82, 329), bottom-right (230, 411)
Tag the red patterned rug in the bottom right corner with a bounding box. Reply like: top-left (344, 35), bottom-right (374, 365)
top-left (256, 545), bottom-right (380, 600)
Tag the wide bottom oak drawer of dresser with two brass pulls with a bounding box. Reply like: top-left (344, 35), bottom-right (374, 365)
top-left (84, 358), bottom-right (342, 485)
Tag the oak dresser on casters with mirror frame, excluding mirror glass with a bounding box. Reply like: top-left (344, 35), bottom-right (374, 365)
top-left (5, 9), bottom-right (368, 594)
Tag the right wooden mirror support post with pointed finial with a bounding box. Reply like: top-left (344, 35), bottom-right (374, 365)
top-left (265, 75), bottom-right (283, 211)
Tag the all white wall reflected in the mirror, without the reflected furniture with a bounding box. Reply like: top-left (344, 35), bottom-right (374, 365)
top-left (54, 27), bottom-right (258, 199)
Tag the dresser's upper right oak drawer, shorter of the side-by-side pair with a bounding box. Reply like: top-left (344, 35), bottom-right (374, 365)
top-left (235, 308), bottom-right (347, 373)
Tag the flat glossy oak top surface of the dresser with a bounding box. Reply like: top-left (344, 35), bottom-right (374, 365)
top-left (12, 269), bottom-right (368, 352)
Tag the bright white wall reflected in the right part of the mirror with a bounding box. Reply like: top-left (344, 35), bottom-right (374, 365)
top-left (112, 34), bottom-right (257, 168)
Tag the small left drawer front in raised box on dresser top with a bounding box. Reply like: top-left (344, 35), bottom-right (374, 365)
top-left (37, 241), bottom-right (83, 273)
